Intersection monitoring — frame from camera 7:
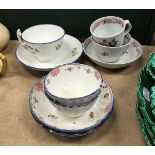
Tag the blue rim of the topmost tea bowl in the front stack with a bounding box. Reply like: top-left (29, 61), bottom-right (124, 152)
top-left (44, 63), bottom-right (103, 101)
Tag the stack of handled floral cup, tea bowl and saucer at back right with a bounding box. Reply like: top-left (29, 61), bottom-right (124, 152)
top-left (84, 16), bottom-right (142, 69)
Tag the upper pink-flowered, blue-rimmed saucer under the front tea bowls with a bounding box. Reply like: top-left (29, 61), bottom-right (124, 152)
top-left (29, 78), bottom-right (114, 133)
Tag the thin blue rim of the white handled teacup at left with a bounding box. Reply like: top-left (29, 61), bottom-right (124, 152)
top-left (21, 24), bottom-right (65, 44)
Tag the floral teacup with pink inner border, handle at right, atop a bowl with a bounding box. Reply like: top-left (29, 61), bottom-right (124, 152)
top-left (90, 16), bottom-right (132, 47)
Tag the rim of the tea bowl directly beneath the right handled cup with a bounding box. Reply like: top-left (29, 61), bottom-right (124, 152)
top-left (90, 33), bottom-right (132, 49)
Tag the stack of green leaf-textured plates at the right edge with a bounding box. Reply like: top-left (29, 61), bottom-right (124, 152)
top-left (136, 53), bottom-right (155, 145)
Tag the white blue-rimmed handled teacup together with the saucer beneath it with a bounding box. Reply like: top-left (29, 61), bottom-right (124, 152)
top-left (16, 24), bottom-right (82, 71)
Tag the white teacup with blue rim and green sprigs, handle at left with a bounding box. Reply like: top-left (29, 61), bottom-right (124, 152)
top-left (17, 24), bottom-right (65, 61)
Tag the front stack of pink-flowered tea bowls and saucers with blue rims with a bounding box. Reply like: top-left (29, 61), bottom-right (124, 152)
top-left (29, 63), bottom-right (114, 137)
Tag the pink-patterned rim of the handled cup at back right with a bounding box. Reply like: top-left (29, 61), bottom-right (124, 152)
top-left (90, 16), bottom-right (125, 39)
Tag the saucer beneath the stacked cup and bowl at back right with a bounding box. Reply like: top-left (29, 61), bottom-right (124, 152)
top-left (83, 38), bottom-right (142, 69)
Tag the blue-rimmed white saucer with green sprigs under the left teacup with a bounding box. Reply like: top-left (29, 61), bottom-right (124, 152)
top-left (16, 35), bottom-right (82, 71)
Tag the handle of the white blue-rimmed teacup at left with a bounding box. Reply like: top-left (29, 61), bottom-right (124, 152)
top-left (16, 29), bottom-right (38, 55)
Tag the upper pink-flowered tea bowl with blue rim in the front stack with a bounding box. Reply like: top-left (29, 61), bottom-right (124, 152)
top-left (44, 63), bottom-right (102, 106)
